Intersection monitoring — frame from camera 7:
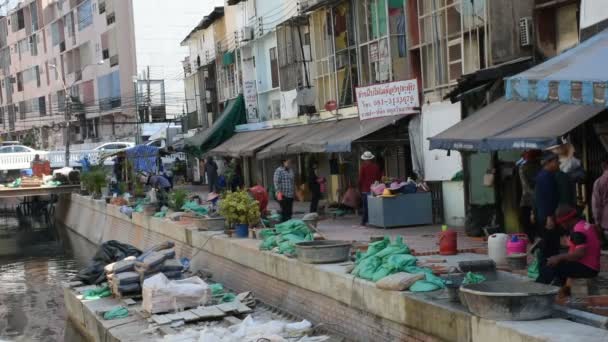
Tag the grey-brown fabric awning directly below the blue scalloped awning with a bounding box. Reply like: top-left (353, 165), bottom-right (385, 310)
top-left (429, 98), bottom-right (605, 152)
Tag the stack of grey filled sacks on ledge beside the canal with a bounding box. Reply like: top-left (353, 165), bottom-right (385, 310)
top-left (105, 242), bottom-right (184, 297)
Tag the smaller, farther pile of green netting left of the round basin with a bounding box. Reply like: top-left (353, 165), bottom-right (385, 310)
top-left (260, 220), bottom-right (313, 255)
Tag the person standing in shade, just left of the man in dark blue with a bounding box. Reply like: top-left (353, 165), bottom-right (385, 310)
top-left (519, 150), bottom-right (541, 241)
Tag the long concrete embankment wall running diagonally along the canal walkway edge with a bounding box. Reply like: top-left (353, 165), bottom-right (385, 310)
top-left (57, 195), bottom-right (608, 342)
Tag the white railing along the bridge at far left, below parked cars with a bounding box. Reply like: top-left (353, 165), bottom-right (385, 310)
top-left (0, 150), bottom-right (186, 171)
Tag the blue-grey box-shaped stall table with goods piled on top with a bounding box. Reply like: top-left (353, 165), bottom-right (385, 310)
top-left (367, 192), bottom-right (433, 228)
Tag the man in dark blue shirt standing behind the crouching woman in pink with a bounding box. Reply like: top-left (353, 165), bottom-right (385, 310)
top-left (534, 152), bottom-right (560, 266)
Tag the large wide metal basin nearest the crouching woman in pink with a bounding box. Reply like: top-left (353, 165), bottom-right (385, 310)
top-left (460, 280), bottom-right (559, 321)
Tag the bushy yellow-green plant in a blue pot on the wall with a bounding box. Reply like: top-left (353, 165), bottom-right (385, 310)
top-left (219, 190), bottom-right (260, 237)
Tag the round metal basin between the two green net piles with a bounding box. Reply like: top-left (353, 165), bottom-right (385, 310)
top-left (296, 240), bottom-right (352, 264)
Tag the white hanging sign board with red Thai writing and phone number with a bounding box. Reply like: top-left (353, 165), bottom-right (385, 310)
top-left (356, 79), bottom-right (420, 120)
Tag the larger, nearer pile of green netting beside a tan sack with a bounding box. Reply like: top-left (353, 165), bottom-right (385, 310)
top-left (352, 236), bottom-right (445, 292)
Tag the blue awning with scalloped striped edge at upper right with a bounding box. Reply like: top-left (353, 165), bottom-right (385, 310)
top-left (505, 30), bottom-right (608, 107)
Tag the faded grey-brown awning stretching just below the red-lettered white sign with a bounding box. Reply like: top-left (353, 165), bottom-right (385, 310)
top-left (256, 115), bottom-right (407, 159)
